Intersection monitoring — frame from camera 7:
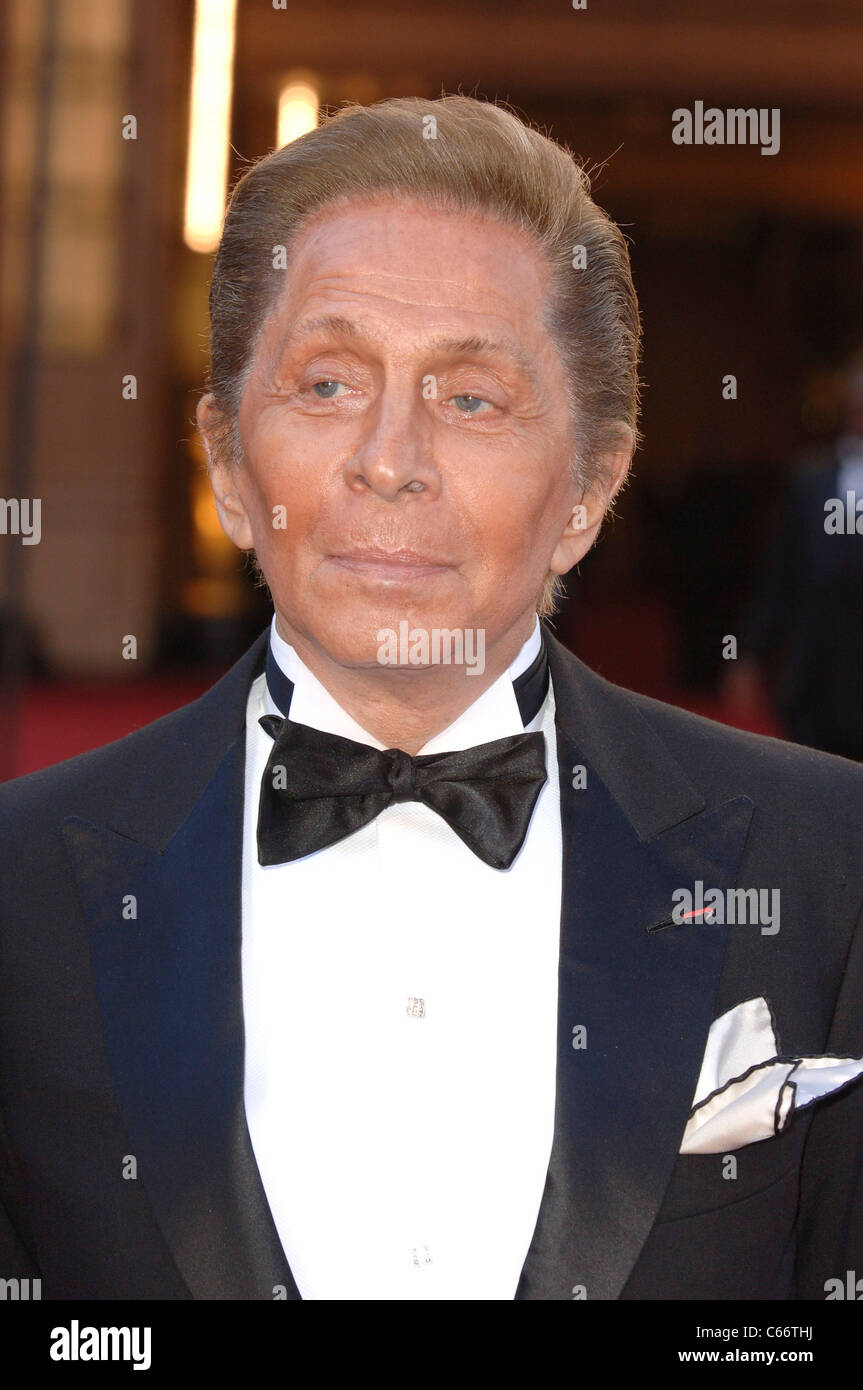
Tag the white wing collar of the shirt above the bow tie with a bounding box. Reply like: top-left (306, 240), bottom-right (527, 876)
top-left (264, 614), bottom-right (545, 753)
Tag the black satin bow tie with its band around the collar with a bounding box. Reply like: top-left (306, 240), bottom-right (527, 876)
top-left (257, 644), bottom-right (548, 869)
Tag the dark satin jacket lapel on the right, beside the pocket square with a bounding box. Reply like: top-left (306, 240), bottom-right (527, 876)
top-left (516, 639), bottom-right (757, 1300)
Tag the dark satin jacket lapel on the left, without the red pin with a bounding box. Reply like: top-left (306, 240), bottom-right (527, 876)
top-left (63, 717), bottom-right (299, 1300)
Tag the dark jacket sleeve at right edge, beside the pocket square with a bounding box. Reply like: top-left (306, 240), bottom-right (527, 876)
top-left (796, 910), bottom-right (863, 1300)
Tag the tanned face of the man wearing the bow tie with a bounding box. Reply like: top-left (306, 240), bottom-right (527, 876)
top-left (199, 197), bottom-right (622, 666)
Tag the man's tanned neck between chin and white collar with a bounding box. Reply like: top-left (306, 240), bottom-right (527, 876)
top-left (275, 610), bottom-right (536, 756)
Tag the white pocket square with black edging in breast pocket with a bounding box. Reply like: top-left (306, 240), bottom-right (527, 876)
top-left (680, 995), bottom-right (863, 1154)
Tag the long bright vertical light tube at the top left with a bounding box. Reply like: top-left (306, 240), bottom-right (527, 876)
top-left (183, 0), bottom-right (236, 252)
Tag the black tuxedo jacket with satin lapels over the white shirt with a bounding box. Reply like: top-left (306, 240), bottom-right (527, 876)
top-left (0, 634), bottom-right (863, 1300)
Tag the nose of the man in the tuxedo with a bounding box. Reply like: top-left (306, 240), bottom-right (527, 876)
top-left (345, 388), bottom-right (441, 502)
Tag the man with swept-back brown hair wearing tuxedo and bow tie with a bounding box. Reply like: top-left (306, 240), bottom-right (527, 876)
top-left (0, 97), bottom-right (863, 1300)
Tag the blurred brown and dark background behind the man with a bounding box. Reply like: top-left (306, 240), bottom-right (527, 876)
top-left (0, 0), bottom-right (863, 777)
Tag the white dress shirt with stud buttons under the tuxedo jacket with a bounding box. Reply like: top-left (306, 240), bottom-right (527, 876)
top-left (242, 619), bottom-right (561, 1300)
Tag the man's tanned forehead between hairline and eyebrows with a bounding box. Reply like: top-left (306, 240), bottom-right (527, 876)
top-left (257, 196), bottom-right (550, 352)
